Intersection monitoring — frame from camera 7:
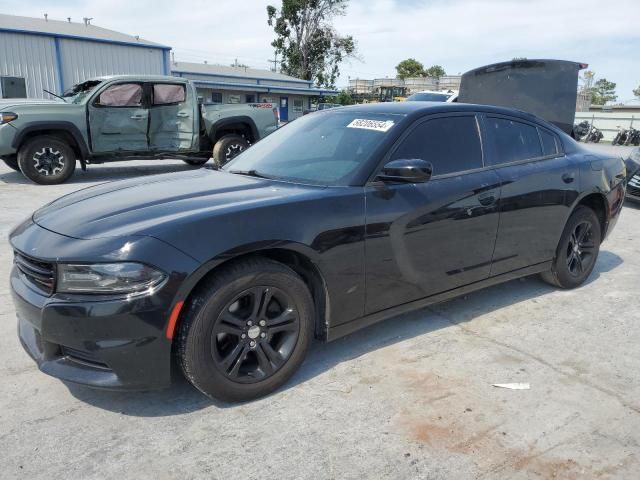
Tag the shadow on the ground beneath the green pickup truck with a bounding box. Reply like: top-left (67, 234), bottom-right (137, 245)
top-left (0, 160), bottom-right (200, 185)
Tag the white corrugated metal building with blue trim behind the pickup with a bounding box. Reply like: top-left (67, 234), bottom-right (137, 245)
top-left (0, 15), bottom-right (171, 98)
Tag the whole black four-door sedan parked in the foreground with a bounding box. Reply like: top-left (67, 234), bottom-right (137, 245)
top-left (10, 102), bottom-right (625, 401)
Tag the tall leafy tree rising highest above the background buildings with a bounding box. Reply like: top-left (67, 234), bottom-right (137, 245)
top-left (267, 0), bottom-right (356, 88)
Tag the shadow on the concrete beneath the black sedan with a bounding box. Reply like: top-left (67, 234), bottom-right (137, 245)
top-left (68, 251), bottom-right (623, 417)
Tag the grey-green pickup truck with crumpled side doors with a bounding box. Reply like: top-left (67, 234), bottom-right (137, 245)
top-left (0, 75), bottom-right (278, 185)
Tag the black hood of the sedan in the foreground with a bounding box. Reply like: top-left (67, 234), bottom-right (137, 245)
top-left (33, 168), bottom-right (323, 239)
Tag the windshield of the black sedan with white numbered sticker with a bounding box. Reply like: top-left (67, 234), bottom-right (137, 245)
top-left (223, 109), bottom-right (402, 185)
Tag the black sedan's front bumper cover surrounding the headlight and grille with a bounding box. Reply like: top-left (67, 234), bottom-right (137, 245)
top-left (10, 218), bottom-right (198, 390)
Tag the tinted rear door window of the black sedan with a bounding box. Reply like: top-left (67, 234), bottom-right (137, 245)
top-left (485, 117), bottom-right (542, 165)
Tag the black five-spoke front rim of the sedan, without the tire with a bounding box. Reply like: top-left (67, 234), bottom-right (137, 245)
top-left (211, 285), bottom-right (300, 383)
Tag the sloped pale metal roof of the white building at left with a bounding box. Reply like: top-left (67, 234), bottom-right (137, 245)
top-left (0, 14), bottom-right (171, 49)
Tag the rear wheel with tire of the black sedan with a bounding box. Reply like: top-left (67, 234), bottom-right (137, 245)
top-left (542, 206), bottom-right (602, 289)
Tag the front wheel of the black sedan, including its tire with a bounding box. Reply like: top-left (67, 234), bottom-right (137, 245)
top-left (176, 257), bottom-right (314, 402)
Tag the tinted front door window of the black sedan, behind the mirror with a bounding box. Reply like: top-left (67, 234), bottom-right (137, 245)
top-left (392, 115), bottom-right (483, 176)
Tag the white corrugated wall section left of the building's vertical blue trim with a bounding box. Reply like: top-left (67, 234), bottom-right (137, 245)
top-left (0, 32), bottom-right (59, 98)
